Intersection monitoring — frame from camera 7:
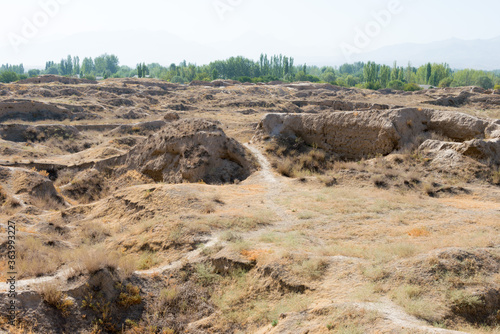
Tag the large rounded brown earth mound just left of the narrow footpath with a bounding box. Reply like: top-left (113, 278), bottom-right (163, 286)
top-left (120, 119), bottom-right (254, 184)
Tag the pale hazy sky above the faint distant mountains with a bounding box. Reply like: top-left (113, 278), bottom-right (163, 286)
top-left (0, 0), bottom-right (500, 65)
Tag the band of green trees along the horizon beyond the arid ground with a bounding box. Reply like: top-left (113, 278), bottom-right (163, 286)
top-left (0, 54), bottom-right (500, 91)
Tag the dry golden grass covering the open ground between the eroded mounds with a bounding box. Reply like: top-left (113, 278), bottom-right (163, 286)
top-left (0, 82), bottom-right (500, 333)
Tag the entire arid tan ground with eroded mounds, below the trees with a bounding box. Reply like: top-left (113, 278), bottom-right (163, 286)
top-left (0, 76), bottom-right (500, 334)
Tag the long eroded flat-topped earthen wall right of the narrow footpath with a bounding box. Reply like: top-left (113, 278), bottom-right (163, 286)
top-left (257, 108), bottom-right (500, 163)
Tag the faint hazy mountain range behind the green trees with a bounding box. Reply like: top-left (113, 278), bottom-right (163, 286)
top-left (0, 31), bottom-right (500, 70)
